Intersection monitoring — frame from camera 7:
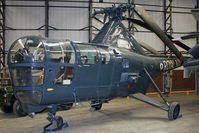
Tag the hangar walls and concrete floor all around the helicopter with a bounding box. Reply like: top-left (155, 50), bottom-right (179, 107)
top-left (0, 0), bottom-right (199, 133)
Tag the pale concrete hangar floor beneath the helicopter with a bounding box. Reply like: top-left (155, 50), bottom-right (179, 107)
top-left (0, 94), bottom-right (199, 133)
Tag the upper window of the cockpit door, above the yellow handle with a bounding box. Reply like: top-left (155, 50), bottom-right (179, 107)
top-left (47, 42), bottom-right (75, 64)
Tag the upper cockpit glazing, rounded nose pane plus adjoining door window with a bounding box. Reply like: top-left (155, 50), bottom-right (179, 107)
top-left (9, 36), bottom-right (75, 64)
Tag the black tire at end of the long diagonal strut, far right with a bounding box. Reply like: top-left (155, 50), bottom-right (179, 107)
top-left (168, 102), bottom-right (180, 120)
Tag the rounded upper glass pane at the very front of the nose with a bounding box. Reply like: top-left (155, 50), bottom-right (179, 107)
top-left (10, 37), bottom-right (44, 63)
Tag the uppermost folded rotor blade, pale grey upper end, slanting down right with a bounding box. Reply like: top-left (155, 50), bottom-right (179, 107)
top-left (135, 6), bottom-right (183, 62)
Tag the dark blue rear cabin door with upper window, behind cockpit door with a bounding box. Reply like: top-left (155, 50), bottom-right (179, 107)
top-left (74, 44), bottom-right (99, 100)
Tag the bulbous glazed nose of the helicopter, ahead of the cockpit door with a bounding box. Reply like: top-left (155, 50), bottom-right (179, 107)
top-left (8, 36), bottom-right (45, 105)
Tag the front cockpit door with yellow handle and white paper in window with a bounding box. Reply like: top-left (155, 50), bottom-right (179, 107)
top-left (43, 40), bottom-right (76, 102)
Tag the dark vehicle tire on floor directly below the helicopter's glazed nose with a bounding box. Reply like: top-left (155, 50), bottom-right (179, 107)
top-left (13, 100), bottom-right (27, 117)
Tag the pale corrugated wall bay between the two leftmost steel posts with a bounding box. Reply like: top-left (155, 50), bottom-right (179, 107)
top-left (5, 1), bottom-right (45, 50)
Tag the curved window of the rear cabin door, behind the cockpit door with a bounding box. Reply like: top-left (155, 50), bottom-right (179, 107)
top-left (77, 45), bottom-right (98, 64)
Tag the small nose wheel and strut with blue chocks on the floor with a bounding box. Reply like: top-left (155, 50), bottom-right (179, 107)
top-left (43, 106), bottom-right (68, 133)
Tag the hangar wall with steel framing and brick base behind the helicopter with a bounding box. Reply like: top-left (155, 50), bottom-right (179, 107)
top-left (0, 0), bottom-right (199, 92)
